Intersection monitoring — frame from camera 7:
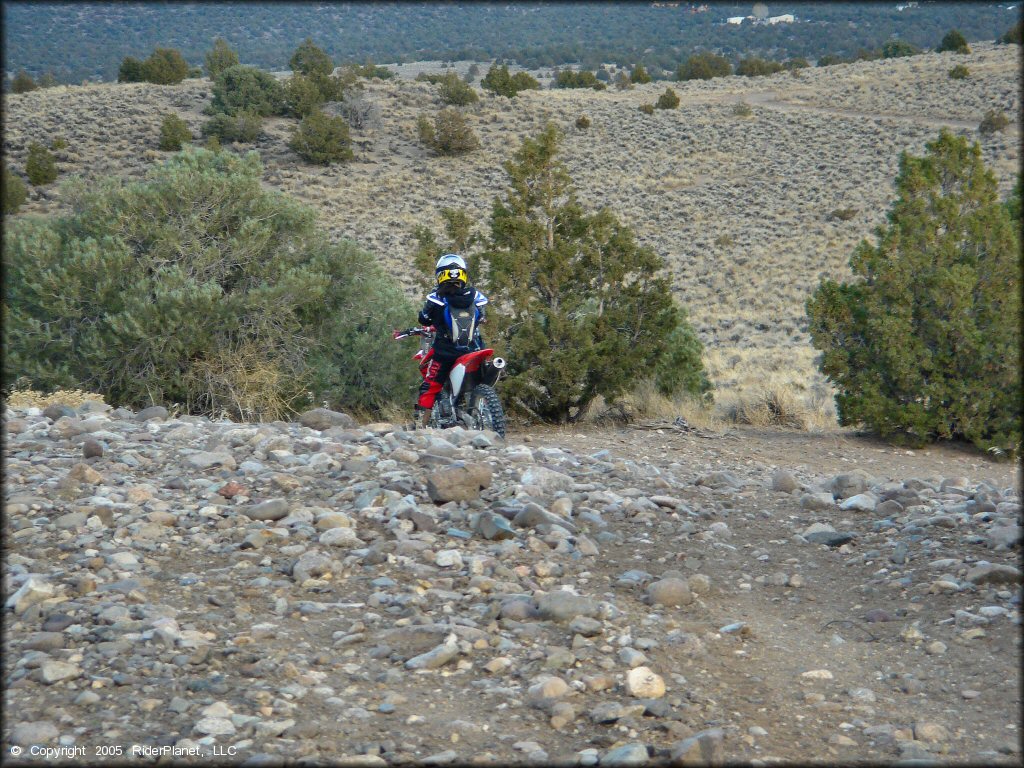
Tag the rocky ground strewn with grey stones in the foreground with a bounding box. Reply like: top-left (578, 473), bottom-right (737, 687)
top-left (3, 402), bottom-right (1021, 766)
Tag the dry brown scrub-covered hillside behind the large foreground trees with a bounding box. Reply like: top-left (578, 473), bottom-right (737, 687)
top-left (4, 44), bottom-right (1021, 429)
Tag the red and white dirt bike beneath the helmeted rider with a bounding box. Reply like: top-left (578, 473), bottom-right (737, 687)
top-left (392, 326), bottom-right (505, 437)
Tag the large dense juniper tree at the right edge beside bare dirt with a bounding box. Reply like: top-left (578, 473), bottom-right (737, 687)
top-left (807, 130), bottom-right (1021, 453)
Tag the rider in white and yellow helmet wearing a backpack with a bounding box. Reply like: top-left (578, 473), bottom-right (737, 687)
top-left (413, 253), bottom-right (487, 428)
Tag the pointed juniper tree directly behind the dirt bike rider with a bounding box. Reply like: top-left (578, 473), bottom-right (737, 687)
top-left (420, 123), bottom-right (700, 422)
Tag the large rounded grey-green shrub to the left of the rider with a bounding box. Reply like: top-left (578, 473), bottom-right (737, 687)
top-left (3, 147), bottom-right (417, 420)
